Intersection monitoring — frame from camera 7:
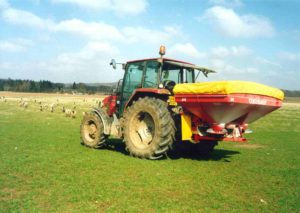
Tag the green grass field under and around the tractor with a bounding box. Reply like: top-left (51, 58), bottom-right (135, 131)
top-left (0, 94), bottom-right (300, 212)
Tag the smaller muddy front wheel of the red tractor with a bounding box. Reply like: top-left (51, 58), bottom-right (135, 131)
top-left (80, 112), bottom-right (107, 149)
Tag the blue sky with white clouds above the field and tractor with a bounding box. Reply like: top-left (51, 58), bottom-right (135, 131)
top-left (0, 0), bottom-right (300, 90)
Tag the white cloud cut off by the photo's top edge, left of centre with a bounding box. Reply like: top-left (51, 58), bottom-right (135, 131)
top-left (52, 0), bottom-right (148, 15)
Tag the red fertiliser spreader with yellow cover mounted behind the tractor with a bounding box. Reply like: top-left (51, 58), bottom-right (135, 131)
top-left (173, 81), bottom-right (283, 142)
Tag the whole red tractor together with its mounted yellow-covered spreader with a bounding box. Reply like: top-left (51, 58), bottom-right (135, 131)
top-left (80, 46), bottom-right (283, 159)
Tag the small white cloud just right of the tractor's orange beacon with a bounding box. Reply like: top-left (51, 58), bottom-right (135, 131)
top-left (167, 43), bottom-right (204, 58)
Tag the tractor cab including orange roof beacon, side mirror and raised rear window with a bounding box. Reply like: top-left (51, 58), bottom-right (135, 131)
top-left (110, 46), bottom-right (215, 116)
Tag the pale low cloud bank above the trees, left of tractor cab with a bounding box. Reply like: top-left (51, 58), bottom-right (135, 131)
top-left (0, 42), bottom-right (124, 83)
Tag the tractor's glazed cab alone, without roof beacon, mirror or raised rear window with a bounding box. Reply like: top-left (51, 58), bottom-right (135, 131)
top-left (117, 58), bottom-right (195, 114)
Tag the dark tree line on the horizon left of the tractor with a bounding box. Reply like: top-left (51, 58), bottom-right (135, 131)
top-left (0, 79), bottom-right (113, 94)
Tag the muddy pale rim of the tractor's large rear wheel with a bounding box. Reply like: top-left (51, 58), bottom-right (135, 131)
top-left (130, 112), bottom-right (155, 149)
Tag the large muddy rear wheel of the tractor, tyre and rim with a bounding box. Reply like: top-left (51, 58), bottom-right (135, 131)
top-left (123, 97), bottom-right (175, 159)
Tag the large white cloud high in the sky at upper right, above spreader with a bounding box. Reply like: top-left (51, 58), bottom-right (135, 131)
top-left (200, 6), bottom-right (275, 38)
